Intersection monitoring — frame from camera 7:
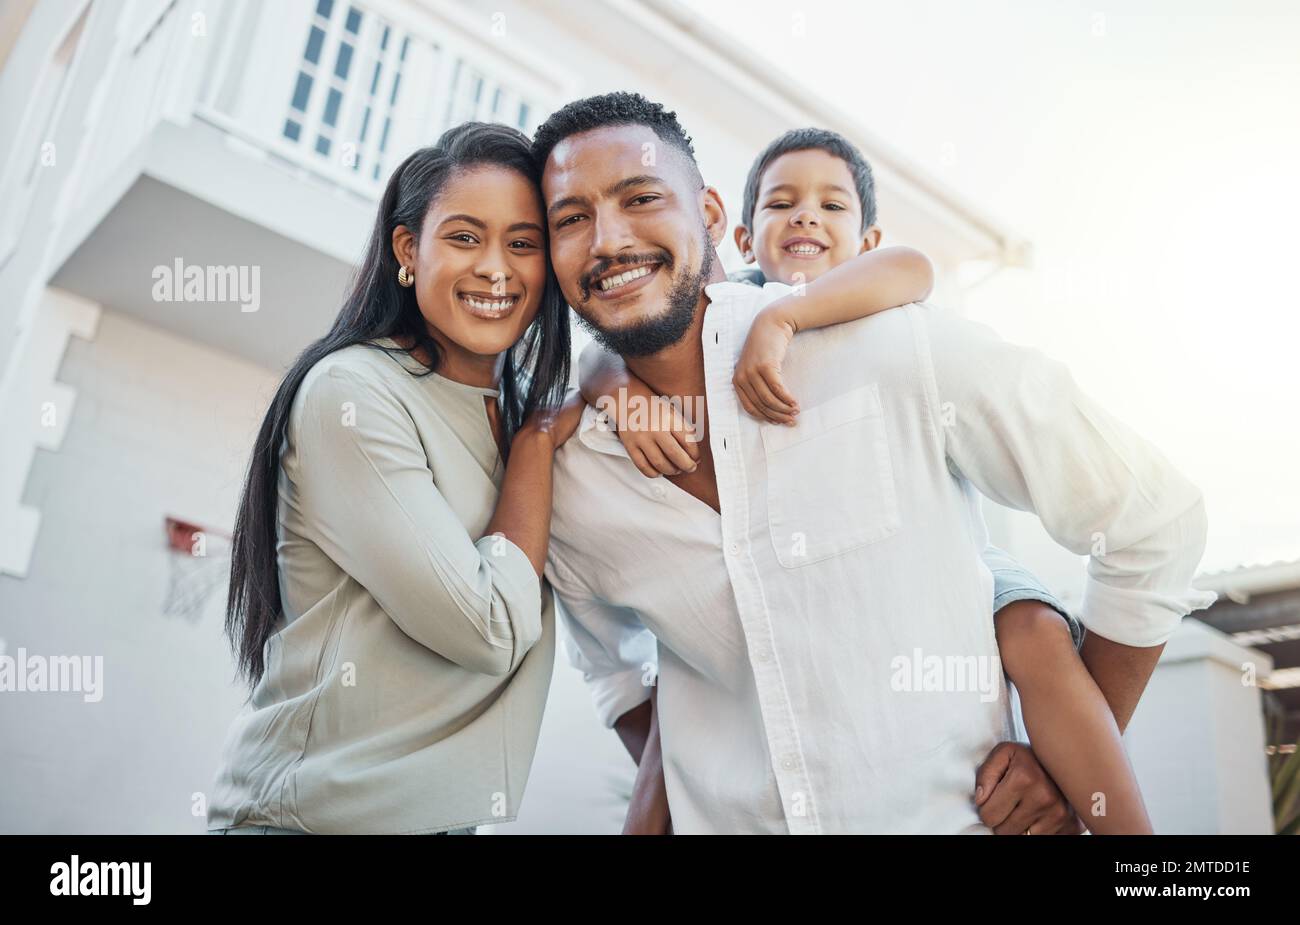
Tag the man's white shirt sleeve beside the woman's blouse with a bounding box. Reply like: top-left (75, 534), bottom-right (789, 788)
top-left (546, 544), bottom-right (659, 729)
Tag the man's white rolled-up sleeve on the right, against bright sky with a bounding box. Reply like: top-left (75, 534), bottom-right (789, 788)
top-left (913, 307), bottom-right (1214, 647)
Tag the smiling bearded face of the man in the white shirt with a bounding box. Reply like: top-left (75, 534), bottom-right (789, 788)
top-left (542, 125), bottom-right (727, 356)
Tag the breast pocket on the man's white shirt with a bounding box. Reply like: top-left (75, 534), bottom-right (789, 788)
top-left (762, 383), bottom-right (901, 569)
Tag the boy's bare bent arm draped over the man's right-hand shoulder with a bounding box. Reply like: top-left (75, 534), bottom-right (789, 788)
top-left (733, 247), bottom-right (935, 425)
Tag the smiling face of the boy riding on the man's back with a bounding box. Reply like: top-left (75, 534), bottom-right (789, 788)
top-left (736, 148), bottom-right (880, 286)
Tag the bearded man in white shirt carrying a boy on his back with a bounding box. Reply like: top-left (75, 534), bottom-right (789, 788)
top-left (534, 94), bottom-right (1205, 833)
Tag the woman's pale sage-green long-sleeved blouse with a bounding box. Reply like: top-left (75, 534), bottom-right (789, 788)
top-left (208, 339), bottom-right (555, 834)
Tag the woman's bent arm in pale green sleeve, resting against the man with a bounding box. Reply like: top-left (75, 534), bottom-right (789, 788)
top-left (291, 366), bottom-right (579, 674)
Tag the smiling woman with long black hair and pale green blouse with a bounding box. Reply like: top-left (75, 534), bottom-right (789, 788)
top-left (208, 123), bottom-right (581, 834)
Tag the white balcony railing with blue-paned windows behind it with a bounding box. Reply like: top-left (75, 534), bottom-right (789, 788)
top-left (63, 0), bottom-right (573, 211)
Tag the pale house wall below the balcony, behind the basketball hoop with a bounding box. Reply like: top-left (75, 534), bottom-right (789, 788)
top-left (0, 312), bottom-right (274, 833)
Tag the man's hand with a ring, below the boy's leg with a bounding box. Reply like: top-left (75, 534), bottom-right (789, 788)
top-left (975, 742), bottom-right (1083, 835)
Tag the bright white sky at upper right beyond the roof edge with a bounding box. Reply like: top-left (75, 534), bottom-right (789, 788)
top-left (697, 0), bottom-right (1300, 569)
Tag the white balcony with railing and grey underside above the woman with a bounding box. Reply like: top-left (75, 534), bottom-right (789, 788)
top-left (39, 0), bottom-right (568, 369)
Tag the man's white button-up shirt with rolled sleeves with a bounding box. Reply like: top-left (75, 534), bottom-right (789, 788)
top-left (547, 282), bottom-right (1213, 833)
